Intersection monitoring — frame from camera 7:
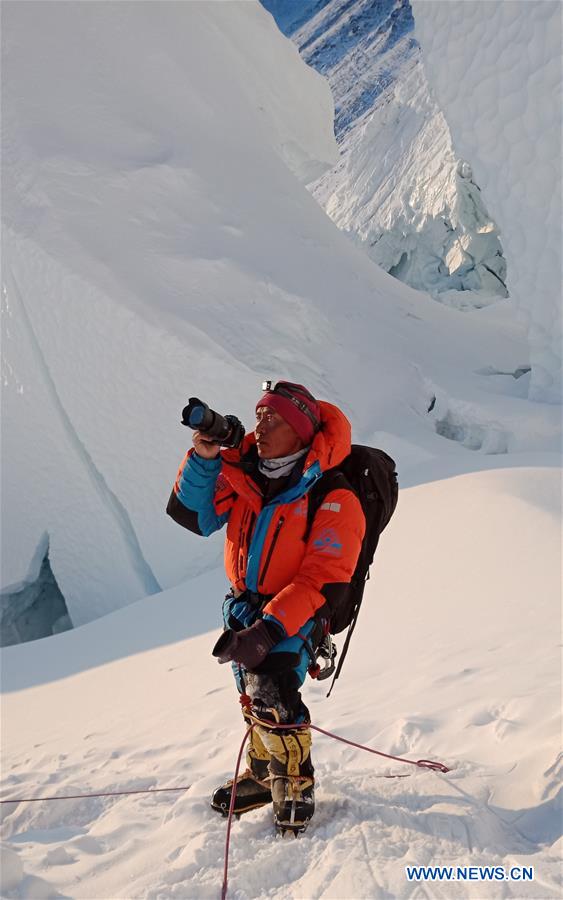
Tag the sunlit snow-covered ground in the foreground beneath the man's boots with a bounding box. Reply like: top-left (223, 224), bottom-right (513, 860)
top-left (2, 464), bottom-right (561, 900)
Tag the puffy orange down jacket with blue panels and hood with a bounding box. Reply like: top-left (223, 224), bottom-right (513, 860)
top-left (167, 401), bottom-right (365, 637)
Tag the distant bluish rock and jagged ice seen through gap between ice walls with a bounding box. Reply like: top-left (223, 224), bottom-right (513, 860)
top-left (262, 0), bottom-right (507, 309)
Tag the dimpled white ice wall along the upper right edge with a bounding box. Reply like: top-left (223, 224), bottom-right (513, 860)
top-left (412, 0), bottom-right (562, 402)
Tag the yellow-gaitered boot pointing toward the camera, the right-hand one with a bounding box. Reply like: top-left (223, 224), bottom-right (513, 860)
top-left (255, 727), bottom-right (315, 837)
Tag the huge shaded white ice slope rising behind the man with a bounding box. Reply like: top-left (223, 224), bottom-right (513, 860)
top-left (1, 2), bottom-right (560, 625)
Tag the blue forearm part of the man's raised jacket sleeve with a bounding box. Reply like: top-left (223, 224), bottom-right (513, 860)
top-left (176, 452), bottom-right (229, 537)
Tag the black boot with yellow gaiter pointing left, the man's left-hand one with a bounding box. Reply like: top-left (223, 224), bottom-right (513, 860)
top-left (211, 729), bottom-right (272, 816)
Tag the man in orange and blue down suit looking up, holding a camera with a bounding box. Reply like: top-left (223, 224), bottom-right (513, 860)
top-left (167, 381), bottom-right (365, 834)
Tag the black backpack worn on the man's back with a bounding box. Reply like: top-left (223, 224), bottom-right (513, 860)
top-left (304, 444), bottom-right (399, 694)
